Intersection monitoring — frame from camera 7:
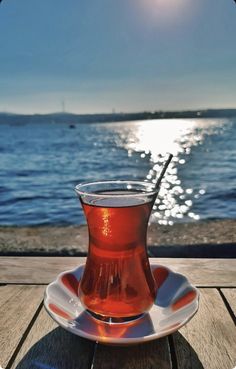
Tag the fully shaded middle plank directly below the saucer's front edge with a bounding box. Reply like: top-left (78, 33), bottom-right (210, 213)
top-left (93, 338), bottom-right (172, 369)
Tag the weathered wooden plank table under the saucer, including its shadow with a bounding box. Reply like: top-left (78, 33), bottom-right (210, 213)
top-left (0, 257), bottom-right (236, 369)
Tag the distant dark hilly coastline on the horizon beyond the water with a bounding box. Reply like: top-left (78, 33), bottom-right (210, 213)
top-left (0, 109), bottom-right (236, 124)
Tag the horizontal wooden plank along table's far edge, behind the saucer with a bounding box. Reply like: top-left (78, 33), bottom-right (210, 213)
top-left (0, 256), bottom-right (236, 287)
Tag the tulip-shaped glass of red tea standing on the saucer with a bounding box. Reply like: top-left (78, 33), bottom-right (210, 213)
top-left (76, 181), bottom-right (158, 322)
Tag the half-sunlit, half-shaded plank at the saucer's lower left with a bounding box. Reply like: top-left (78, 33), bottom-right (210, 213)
top-left (9, 309), bottom-right (95, 369)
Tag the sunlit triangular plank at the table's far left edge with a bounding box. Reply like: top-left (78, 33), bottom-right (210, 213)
top-left (0, 286), bottom-right (44, 368)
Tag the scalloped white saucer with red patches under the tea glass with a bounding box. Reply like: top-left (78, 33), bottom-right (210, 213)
top-left (44, 264), bottom-right (199, 345)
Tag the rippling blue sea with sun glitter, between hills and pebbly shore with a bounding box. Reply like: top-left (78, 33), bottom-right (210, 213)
top-left (0, 118), bottom-right (236, 226)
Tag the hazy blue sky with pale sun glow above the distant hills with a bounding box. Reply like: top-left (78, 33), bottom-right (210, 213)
top-left (0, 0), bottom-right (236, 114)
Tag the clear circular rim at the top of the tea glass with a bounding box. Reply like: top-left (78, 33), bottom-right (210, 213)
top-left (75, 180), bottom-right (159, 198)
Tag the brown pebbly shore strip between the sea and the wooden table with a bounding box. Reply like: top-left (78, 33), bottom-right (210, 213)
top-left (0, 220), bottom-right (236, 257)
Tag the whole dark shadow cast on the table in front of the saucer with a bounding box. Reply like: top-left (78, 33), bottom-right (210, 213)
top-left (16, 328), bottom-right (204, 369)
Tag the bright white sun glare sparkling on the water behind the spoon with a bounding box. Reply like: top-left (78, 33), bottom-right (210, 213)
top-left (105, 119), bottom-right (227, 224)
